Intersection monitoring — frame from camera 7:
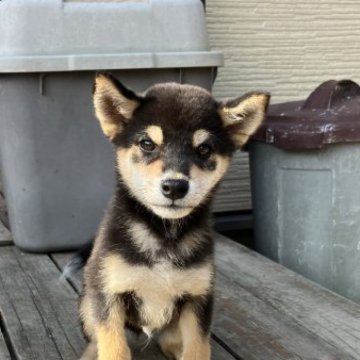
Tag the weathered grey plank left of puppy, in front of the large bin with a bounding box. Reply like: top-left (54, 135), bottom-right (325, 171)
top-left (0, 246), bottom-right (85, 360)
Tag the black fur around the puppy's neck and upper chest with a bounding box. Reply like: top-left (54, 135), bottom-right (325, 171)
top-left (96, 182), bottom-right (213, 267)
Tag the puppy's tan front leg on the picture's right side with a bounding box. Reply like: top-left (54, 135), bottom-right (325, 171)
top-left (179, 295), bottom-right (212, 360)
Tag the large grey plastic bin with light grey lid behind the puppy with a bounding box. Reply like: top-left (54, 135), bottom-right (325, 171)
top-left (0, 0), bottom-right (222, 251)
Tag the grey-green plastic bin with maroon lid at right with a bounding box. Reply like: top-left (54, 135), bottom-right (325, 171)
top-left (250, 81), bottom-right (360, 301)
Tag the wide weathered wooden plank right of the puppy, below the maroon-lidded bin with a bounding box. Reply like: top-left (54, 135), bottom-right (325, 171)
top-left (214, 235), bottom-right (360, 360)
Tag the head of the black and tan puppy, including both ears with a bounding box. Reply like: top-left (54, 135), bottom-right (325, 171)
top-left (94, 74), bottom-right (269, 219)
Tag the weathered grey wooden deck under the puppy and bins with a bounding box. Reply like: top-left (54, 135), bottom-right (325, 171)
top-left (0, 187), bottom-right (360, 360)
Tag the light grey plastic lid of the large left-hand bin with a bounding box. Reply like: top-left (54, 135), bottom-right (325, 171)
top-left (0, 0), bottom-right (223, 73)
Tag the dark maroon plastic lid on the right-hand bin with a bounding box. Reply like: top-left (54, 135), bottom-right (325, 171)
top-left (252, 80), bottom-right (360, 150)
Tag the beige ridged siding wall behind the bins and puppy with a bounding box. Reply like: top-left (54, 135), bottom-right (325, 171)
top-left (207, 0), bottom-right (360, 208)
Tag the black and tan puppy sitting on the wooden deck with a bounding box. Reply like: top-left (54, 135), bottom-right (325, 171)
top-left (80, 74), bottom-right (269, 360)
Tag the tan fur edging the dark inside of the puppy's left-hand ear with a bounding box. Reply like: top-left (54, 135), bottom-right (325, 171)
top-left (93, 75), bottom-right (139, 140)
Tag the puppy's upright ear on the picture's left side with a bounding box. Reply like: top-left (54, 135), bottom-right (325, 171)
top-left (93, 73), bottom-right (141, 140)
